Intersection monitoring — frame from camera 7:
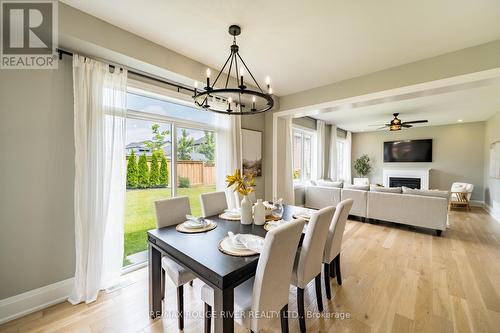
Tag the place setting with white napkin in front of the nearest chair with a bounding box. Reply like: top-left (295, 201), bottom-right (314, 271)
top-left (219, 231), bottom-right (264, 257)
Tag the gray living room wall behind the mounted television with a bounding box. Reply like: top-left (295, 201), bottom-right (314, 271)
top-left (352, 122), bottom-right (485, 200)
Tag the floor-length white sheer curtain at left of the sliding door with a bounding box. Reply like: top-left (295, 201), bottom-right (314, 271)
top-left (69, 54), bottom-right (127, 304)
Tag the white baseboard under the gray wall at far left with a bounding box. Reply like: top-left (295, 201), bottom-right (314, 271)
top-left (0, 278), bottom-right (74, 324)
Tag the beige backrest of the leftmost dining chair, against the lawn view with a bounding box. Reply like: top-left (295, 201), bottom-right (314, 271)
top-left (155, 197), bottom-right (191, 228)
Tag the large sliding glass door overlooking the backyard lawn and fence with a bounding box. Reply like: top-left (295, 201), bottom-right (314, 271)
top-left (123, 88), bottom-right (216, 266)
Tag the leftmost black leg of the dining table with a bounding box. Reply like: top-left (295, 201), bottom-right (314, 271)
top-left (148, 243), bottom-right (162, 319)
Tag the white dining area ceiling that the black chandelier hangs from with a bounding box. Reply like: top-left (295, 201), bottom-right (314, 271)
top-left (63, 0), bottom-right (500, 95)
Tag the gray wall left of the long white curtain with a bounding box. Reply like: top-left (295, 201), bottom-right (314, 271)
top-left (0, 60), bottom-right (75, 299)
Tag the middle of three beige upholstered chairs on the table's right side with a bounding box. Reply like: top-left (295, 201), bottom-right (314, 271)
top-left (291, 206), bottom-right (335, 332)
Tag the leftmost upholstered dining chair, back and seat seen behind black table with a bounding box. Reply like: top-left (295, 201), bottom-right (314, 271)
top-left (155, 197), bottom-right (196, 330)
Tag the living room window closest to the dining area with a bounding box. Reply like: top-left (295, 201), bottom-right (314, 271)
top-left (292, 129), bottom-right (314, 182)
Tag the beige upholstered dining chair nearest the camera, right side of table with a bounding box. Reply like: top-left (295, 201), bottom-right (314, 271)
top-left (201, 220), bottom-right (305, 333)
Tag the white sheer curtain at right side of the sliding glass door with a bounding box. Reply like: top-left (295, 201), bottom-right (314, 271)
top-left (215, 114), bottom-right (241, 208)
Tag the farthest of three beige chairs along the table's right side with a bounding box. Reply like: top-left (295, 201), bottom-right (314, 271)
top-left (323, 199), bottom-right (354, 299)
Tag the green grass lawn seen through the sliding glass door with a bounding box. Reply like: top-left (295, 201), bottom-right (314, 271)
top-left (124, 186), bottom-right (215, 265)
